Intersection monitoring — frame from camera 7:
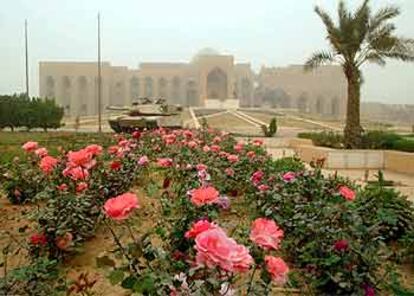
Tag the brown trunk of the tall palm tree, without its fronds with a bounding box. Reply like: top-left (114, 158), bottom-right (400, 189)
top-left (344, 67), bottom-right (363, 149)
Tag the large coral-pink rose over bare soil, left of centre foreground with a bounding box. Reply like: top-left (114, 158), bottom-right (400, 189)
top-left (104, 193), bottom-right (139, 220)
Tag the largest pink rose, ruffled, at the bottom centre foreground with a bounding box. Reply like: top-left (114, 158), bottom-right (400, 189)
top-left (195, 228), bottom-right (253, 272)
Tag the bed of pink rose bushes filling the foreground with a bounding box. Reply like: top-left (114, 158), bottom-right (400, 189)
top-left (0, 129), bottom-right (414, 295)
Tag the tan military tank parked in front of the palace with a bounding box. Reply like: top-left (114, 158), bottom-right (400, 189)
top-left (107, 98), bottom-right (183, 133)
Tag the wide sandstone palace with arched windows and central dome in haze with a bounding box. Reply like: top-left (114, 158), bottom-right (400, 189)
top-left (39, 49), bottom-right (346, 116)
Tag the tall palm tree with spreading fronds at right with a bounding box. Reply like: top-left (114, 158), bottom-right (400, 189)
top-left (305, 0), bottom-right (414, 148)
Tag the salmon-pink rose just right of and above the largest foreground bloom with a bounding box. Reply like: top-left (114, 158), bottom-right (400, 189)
top-left (250, 218), bottom-right (283, 250)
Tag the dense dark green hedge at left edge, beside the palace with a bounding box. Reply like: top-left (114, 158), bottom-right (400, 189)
top-left (0, 94), bottom-right (64, 131)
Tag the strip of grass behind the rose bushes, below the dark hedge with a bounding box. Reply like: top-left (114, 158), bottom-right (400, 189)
top-left (0, 132), bottom-right (113, 165)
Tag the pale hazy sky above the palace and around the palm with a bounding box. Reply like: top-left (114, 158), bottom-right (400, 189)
top-left (0, 0), bottom-right (414, 104)
